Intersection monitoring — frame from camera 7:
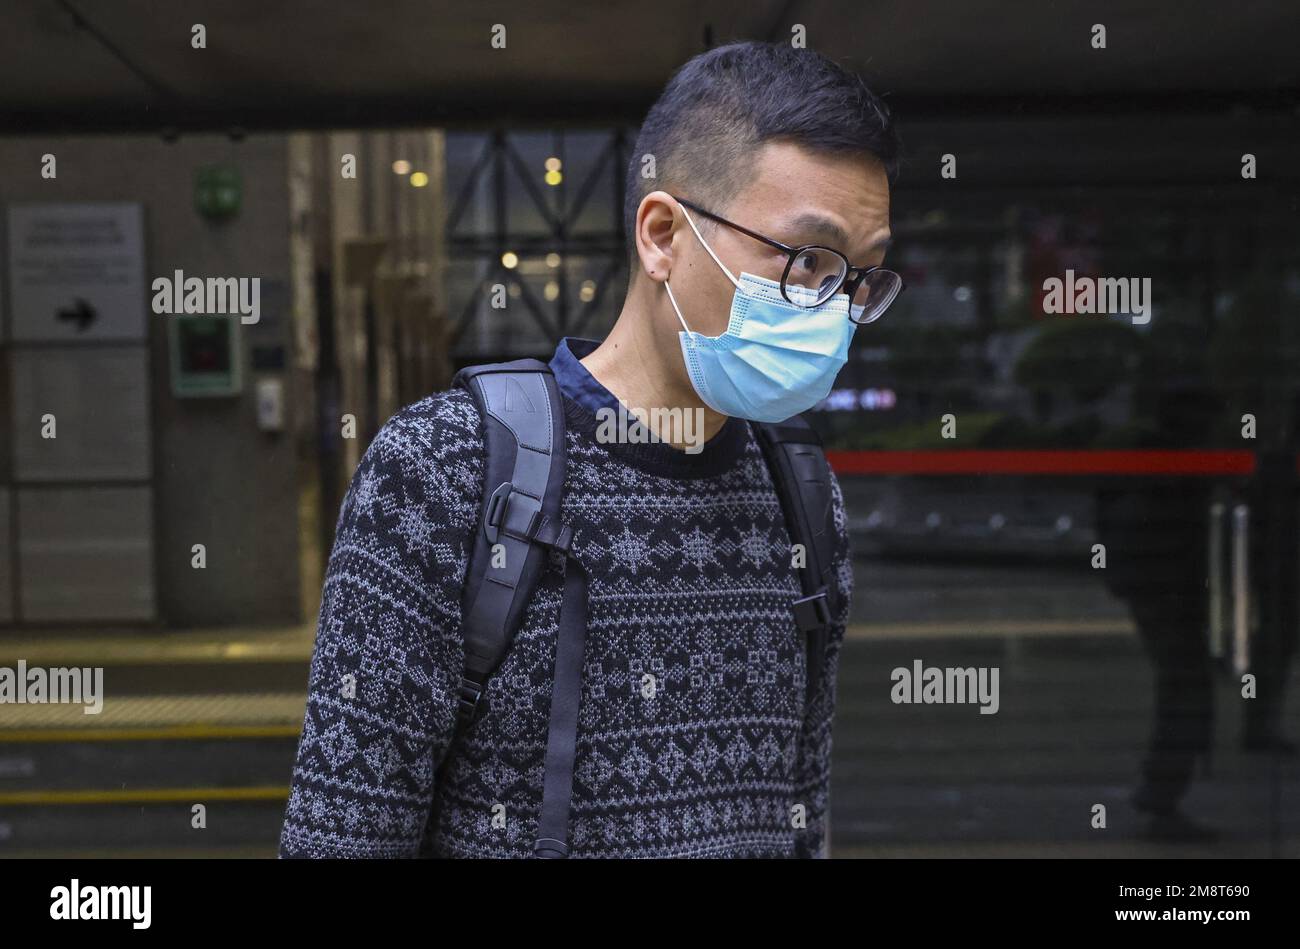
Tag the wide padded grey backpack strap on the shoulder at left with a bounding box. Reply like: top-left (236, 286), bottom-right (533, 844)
top-left (452, 359), bottom-right (571, 729)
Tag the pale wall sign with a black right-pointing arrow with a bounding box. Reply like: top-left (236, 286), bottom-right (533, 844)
top-left (9, 202), bottom-right (148, 342)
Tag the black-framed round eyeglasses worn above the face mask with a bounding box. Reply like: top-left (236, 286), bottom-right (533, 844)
top-left (670, 195), bottom-right (905, 324)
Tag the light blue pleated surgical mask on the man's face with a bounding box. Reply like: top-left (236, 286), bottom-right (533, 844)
top-left (663, 209), bottom-right (861, 421)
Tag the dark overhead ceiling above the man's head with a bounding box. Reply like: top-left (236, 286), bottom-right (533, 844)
top-left (0, 0), bottom-right (1300, 133)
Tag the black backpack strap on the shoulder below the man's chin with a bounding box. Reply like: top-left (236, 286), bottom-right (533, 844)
top-left (751, 416), bottom-right (839, 699)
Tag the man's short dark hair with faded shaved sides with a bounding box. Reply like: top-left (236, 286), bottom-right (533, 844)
top-left (623, 42), bottom-right (901, 262)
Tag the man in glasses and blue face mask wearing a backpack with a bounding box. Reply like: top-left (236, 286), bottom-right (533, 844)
top-left (281, 43), bottom-right (902, 857)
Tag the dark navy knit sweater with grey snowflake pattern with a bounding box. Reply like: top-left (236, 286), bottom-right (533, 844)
top-left (280, 379), bottom-right (852, 858)
